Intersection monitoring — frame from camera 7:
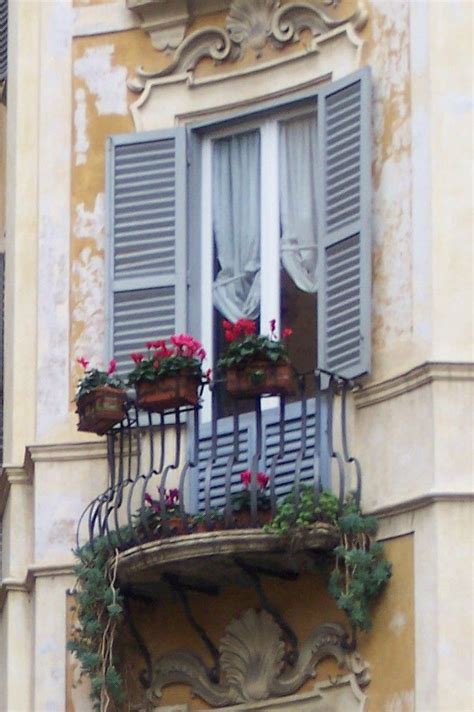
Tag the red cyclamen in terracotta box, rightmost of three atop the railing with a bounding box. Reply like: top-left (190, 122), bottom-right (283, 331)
top-left (218, 319), bottom-right (296, 398)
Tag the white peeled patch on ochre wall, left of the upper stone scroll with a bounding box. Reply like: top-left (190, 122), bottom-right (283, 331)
top-left (74, 45), bottom-right (127, 115)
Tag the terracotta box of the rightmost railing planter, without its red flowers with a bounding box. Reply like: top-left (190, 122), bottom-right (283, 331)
top-left (226, 361), bottom-right (297, 398)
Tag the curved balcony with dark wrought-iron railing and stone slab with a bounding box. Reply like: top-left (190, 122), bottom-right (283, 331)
top-left (78, 372), bottom-right (361, 590)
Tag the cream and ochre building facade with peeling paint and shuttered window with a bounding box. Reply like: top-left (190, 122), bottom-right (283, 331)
top-left (0, 0), bottom-right (473, 712)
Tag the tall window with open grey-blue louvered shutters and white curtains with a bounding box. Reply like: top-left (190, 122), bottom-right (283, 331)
top-left (107, 68), bottom-right (371, 500)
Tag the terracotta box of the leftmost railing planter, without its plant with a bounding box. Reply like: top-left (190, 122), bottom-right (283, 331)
top-left (76, 386), bottom-right (127, 435)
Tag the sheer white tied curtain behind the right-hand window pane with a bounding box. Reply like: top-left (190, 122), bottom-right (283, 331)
top-left (280, 116), bottom-right (318, 293)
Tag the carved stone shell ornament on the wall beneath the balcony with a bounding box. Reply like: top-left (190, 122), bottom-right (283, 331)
top-left (147, 609), bottom-right (369, 709)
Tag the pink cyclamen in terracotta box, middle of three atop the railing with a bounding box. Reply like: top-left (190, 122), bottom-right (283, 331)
top-left (128, 334), bottom-right (206, 413)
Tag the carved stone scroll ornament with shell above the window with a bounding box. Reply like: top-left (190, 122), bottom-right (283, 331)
top-left (128, 0), bottom-right (367, 93)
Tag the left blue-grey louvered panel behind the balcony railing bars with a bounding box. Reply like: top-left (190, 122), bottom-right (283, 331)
top-left (197, 416), bottom-right (255, 511)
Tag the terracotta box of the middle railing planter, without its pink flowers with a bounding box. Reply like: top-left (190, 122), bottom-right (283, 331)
top-left (136, 373), bottom-right (200, 413)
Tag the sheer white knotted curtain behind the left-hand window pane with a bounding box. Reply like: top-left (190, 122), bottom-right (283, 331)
top-left (212, 131), bottom-right (260, 321)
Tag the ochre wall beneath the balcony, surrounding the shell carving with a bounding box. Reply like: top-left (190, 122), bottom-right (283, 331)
top-left (112, 535), bottom-right (415, 712)
